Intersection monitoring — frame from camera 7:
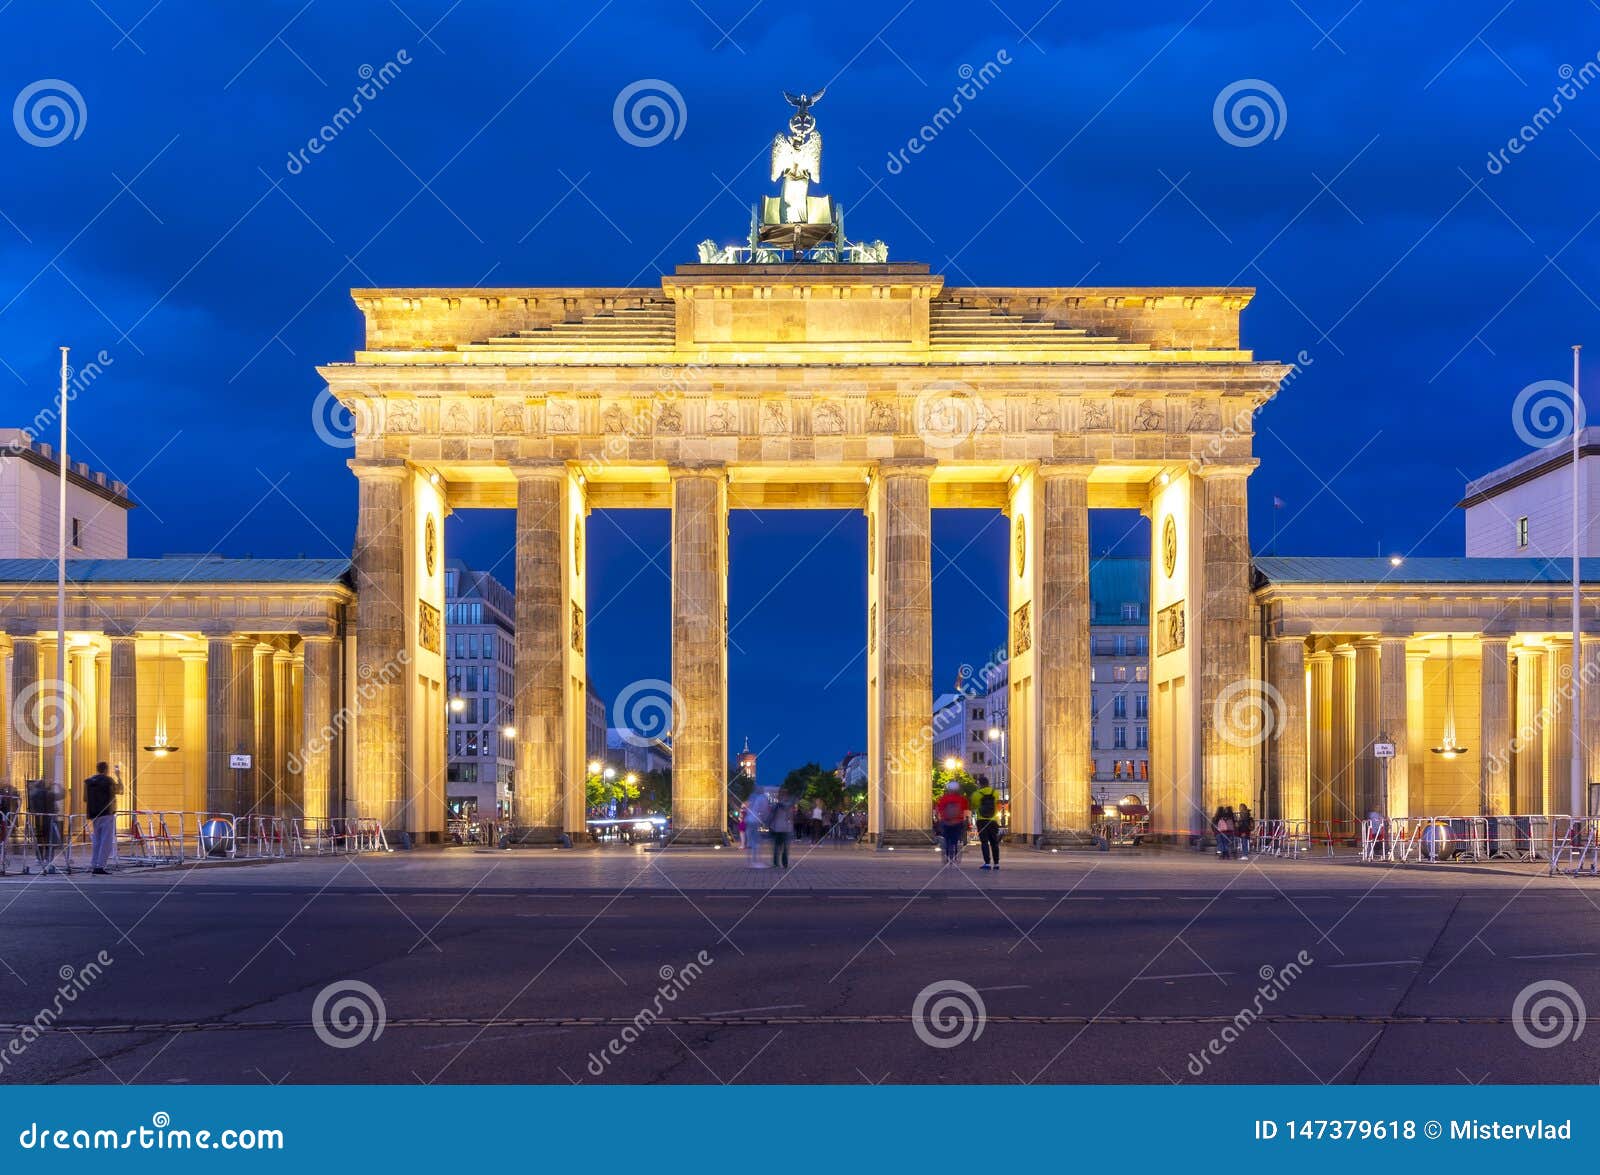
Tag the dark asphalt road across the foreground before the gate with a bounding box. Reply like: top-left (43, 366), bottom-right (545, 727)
top-left (0, 855), bottom-right (1600, 1084)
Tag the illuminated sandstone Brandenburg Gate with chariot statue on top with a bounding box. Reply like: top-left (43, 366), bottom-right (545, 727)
top-left (320, 99), bottom-right (1290, 845)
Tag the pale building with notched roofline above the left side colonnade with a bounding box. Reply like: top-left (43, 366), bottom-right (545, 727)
top-left (0, 429), bottom-right (133, 559)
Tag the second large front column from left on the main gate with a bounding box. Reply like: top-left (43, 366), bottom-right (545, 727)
top-left (512, 463), bottom-right (572, 844)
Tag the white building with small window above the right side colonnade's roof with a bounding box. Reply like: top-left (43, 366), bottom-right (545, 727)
top-left (1458, 427), bottom-right (1600, 559)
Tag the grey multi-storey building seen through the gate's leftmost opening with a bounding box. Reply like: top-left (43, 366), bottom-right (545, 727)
top-left (445, 559), bottom-right (517, 820)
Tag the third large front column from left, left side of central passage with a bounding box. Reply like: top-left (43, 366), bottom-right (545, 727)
top-left (672, 466), bottom-right (728, 844)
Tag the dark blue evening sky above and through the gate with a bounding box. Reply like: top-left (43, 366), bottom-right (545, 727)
top-left (0, 0), bottom-right (1600, 767)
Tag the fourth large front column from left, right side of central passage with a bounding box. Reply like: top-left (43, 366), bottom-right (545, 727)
top-left (877, 463), bottom-right (933, 845)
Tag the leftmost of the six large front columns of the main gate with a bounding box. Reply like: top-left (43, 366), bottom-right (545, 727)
top-left (350, 459), bottom-right (414, 832)
